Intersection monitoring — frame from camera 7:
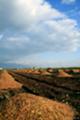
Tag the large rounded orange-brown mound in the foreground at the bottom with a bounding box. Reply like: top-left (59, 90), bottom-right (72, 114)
top-left (0, 93), bottom-right (74, 120)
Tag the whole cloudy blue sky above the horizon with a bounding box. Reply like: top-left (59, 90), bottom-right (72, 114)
top-left (0, 0), bottom-right (80, 67)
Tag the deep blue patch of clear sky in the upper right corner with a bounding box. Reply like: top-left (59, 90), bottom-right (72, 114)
top-left (47, 0), bottom-right (80, 26)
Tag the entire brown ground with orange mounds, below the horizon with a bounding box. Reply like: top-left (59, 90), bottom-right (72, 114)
top-left (0, 69), bottom-right (80, 120)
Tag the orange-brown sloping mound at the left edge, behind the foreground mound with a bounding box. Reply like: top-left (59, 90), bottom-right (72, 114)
top-left (0, 70), bottom-right (22, 89)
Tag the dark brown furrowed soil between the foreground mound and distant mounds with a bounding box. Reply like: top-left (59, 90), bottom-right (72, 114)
top-left (9, 71), bottom-right (80, 120)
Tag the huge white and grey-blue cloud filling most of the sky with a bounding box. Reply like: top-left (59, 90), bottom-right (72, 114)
top-left (0, 0), bottom-right (80, 65)
